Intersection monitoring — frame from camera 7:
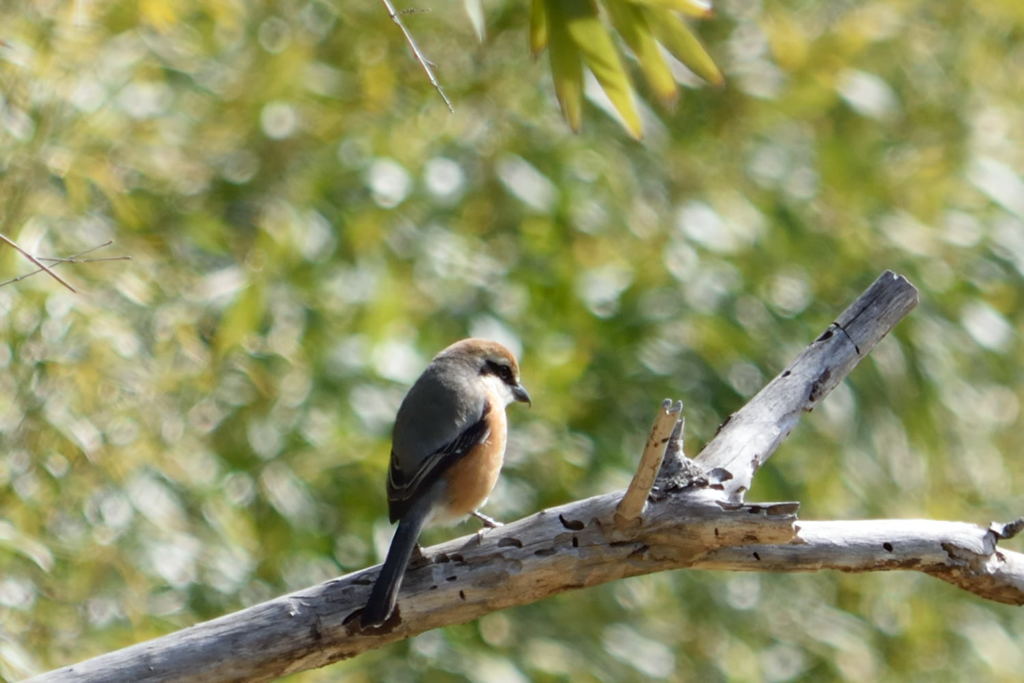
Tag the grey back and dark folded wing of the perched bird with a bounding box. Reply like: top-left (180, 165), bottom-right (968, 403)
top-left (387, 365), bottom-right (489, 521)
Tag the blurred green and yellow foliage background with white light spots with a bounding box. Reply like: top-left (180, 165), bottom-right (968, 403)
top-left (0, 0), bottom-right (1024, 682)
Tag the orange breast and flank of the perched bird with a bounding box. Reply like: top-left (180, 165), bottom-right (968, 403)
top-left (439, 401), bottom-right (507, 518)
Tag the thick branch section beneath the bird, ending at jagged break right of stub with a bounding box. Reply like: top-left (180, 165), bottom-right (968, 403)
top-left (35, 492), bottom-right (796, 681)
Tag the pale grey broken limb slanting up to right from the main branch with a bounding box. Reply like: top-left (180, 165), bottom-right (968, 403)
top-left (694, 270), bottom-right (918, 501)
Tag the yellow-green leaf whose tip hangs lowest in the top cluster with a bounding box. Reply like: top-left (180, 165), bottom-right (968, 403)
top-left (548, 0), bottom-right (643, 137)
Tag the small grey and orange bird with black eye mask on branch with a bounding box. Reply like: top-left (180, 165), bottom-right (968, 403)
top-left (361, 338), bottom-right (532, 627)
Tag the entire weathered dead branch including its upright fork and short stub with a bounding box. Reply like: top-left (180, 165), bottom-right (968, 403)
top-left (35, 272), bottom-right (1024, 681)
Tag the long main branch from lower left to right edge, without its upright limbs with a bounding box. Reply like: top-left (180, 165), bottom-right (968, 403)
top-left (32, 499), bottom-right (1024, 682)
